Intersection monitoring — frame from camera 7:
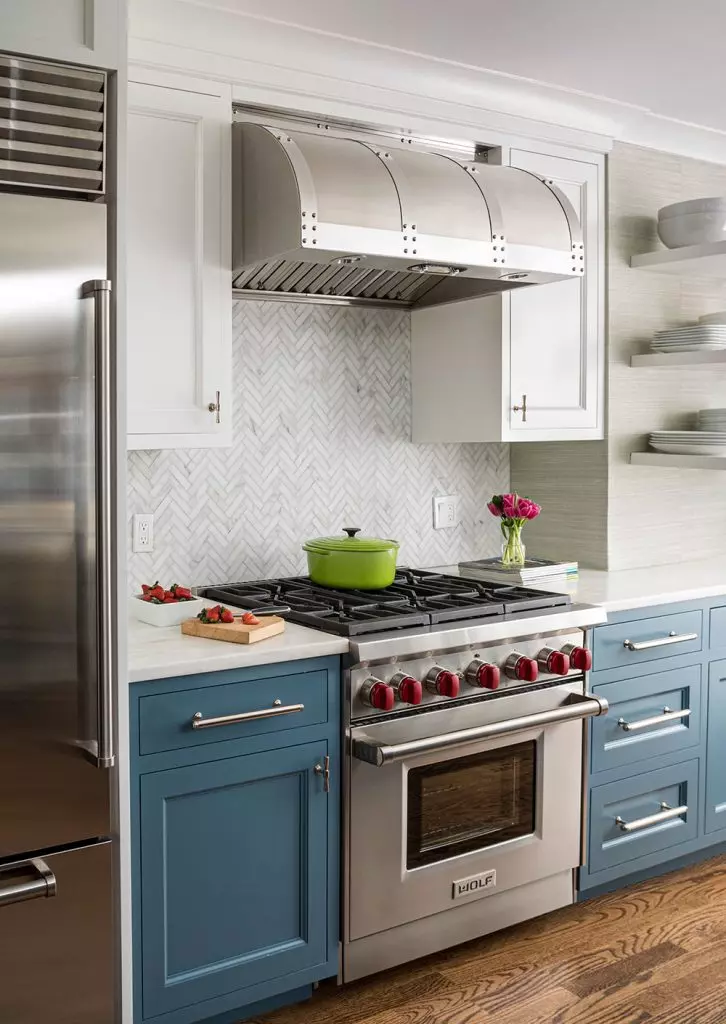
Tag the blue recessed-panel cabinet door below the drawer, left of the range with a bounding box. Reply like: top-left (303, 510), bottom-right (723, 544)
top-left (141, 741), bottom-right (329, 1018)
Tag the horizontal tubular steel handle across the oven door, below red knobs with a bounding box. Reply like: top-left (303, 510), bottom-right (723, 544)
top-left (352, 693), bottom-right (608, 768)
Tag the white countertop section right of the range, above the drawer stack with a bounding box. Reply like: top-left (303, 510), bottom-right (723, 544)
top-left (441, 558), bottom-right (726, 612)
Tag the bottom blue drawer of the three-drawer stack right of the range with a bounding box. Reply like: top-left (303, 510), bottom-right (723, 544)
top-left (588, 759), bottom-right (698, 874)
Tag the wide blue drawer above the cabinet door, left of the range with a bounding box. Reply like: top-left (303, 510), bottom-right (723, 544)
top-left (138, 670), bottom-right (329, 755)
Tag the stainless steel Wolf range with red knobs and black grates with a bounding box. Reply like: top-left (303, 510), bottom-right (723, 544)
top-left (199, 570), bottom-right (607, 981)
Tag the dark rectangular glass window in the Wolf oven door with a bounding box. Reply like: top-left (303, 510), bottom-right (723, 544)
top-left (407, 739), bottom-right (537, 868)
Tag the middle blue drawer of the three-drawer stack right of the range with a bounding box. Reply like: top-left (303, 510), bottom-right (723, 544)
top-left (591, 665), bottom-right (701, 773)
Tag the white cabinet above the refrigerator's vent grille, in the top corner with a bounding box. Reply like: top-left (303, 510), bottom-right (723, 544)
top-left (0, 0), bottom-right (126, 71)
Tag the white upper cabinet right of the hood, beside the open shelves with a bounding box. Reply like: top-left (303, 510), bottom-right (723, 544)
top-left (412, 150), bottom-right (605, 442)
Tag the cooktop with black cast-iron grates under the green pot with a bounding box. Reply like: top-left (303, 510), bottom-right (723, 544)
top-left (200, 568), bottom-right (570, 636)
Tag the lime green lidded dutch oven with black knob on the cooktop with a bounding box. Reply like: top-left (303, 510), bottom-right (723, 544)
top-left (302, 526), bottom-right (399, 590)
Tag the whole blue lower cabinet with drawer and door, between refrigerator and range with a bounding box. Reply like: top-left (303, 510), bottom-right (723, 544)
top-left (131, 657), bottom-right (340, 1024)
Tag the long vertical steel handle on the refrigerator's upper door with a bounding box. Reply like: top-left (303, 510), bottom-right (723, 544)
top-left (81, 281), bottom-right (116, 768)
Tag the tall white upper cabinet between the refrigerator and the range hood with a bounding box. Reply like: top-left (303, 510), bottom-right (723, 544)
top-left (127, 72), bottom-right (231, 449)
